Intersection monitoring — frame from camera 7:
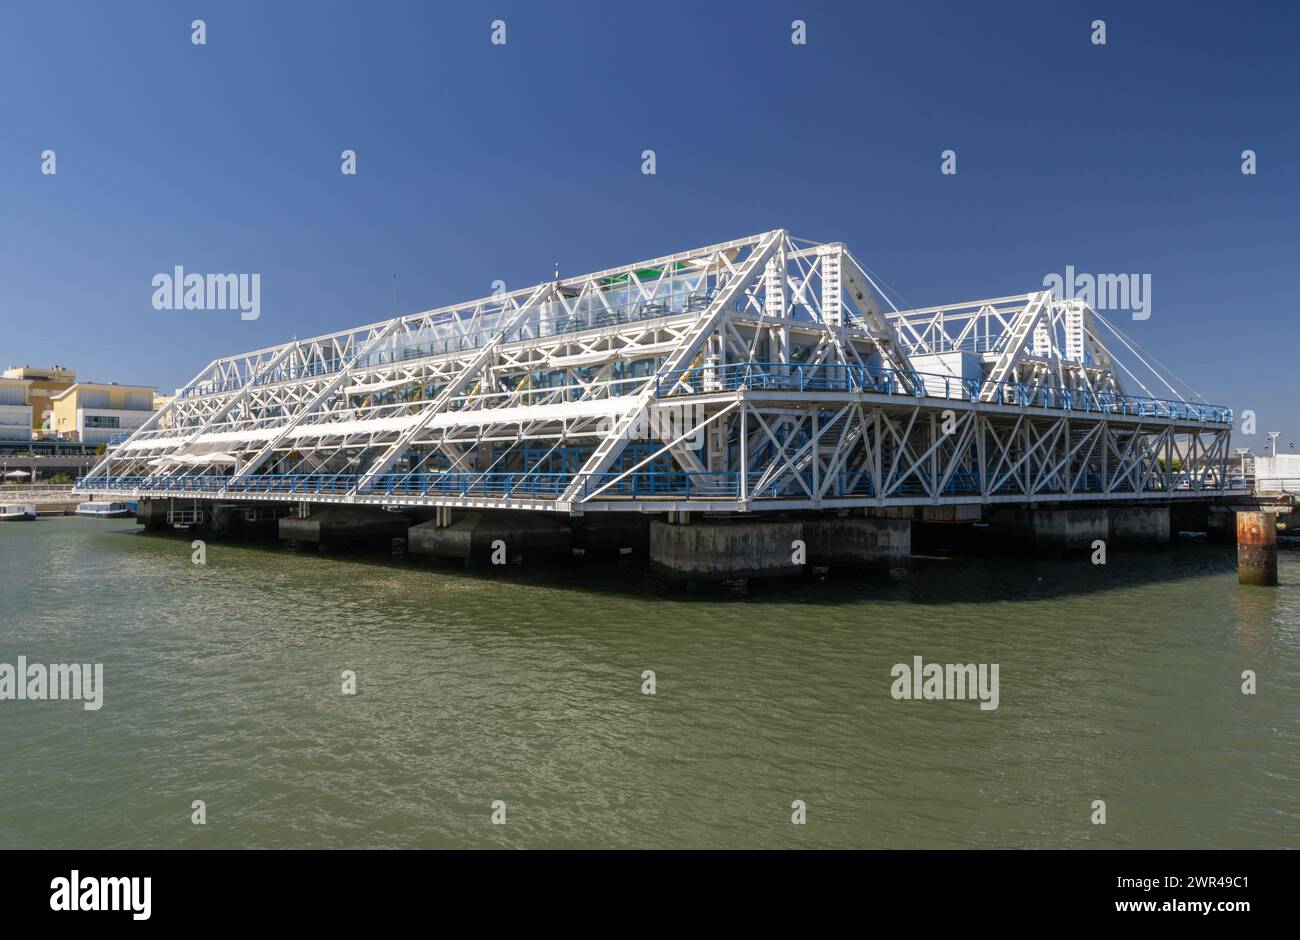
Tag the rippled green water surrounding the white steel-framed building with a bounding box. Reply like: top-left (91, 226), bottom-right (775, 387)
top-left (0, 517), bottom-right (1300, 848)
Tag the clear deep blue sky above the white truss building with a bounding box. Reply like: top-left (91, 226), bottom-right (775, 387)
top-left (0, 0), bottom-right (1300, 451)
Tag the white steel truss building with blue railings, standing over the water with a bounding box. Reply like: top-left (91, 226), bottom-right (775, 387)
top-left (78, 230), bottom-right (1231, 512)
